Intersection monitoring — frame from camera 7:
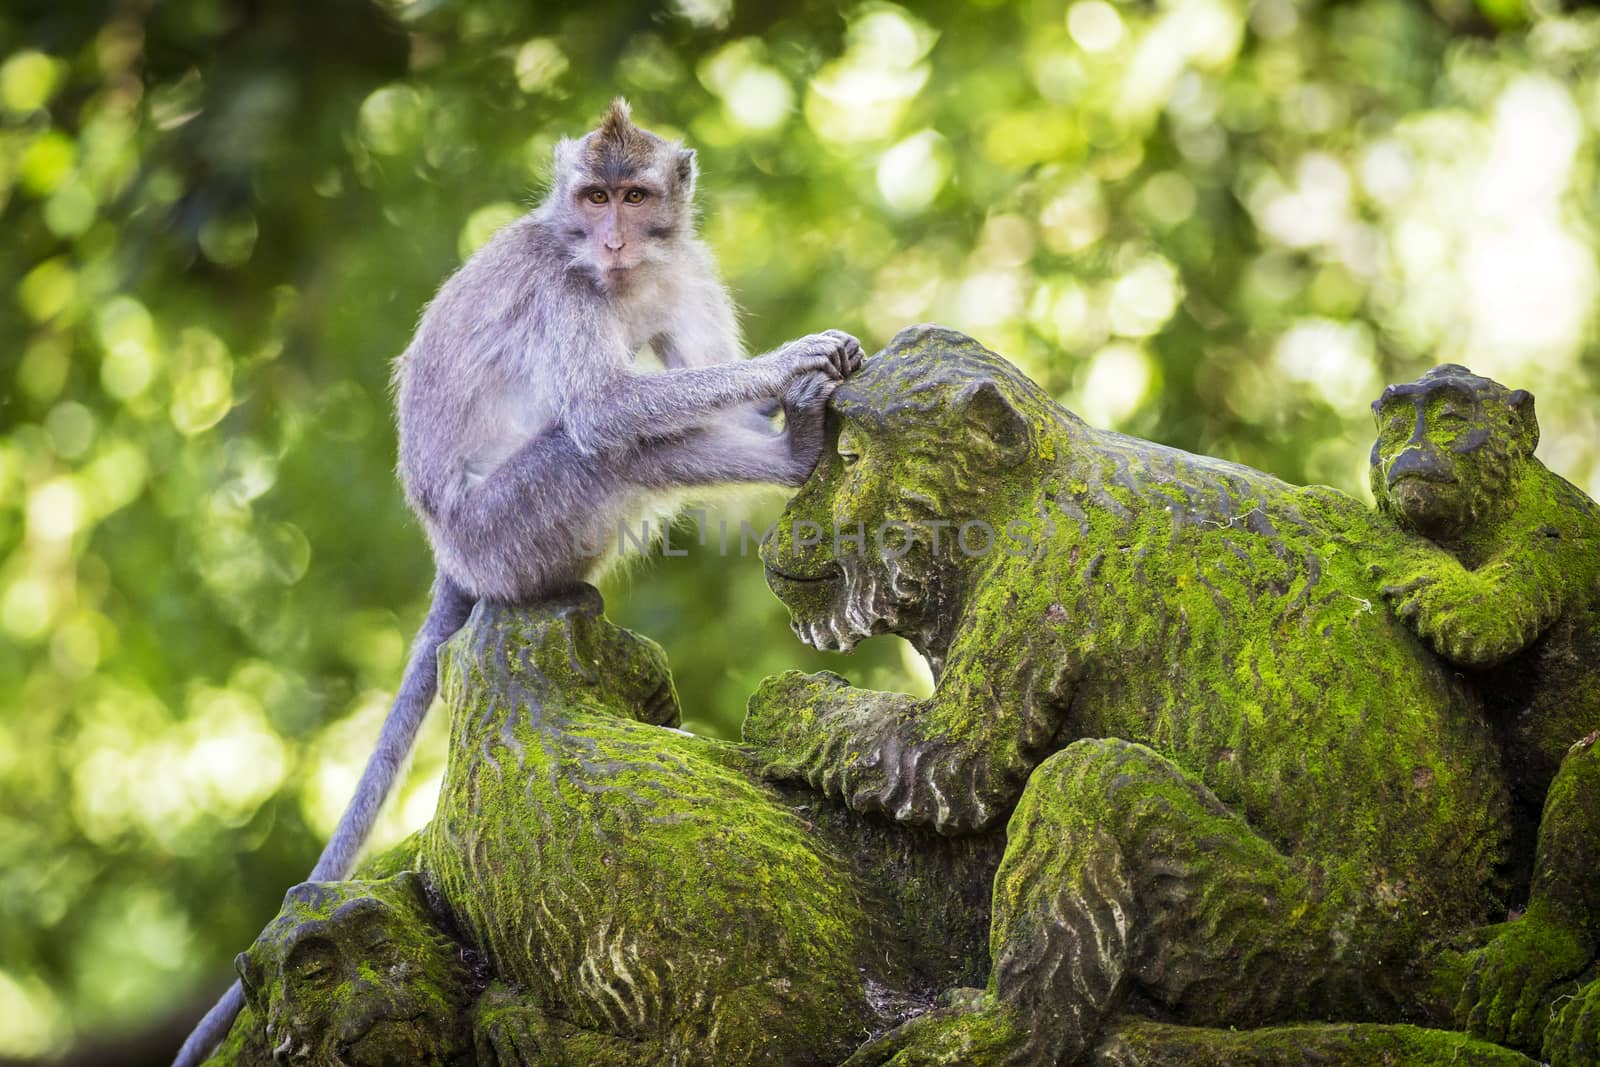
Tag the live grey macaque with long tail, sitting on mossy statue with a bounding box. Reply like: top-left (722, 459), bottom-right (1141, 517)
top-left (174, 99), bottom-right (861, 1067)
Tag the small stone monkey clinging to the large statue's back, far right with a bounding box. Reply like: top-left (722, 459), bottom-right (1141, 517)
top-left (1371, 363), bottom-right (1600, 1062)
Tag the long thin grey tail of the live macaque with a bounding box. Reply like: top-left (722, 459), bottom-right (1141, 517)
top-left (173, 574), bottom-right (474, 1067)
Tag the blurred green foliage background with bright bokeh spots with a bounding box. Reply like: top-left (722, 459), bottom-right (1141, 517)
top-left (0, 0), bottom-right (1600, 1064)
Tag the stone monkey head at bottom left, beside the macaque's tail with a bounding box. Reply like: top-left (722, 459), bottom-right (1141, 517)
top-left (234, 872), bottom-right (475, 1067)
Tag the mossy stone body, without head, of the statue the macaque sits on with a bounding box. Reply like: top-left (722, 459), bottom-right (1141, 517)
top-left (424, 588), bottom-right (882, 1064)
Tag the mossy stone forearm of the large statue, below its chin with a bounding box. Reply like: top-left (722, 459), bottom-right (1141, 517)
top-left (744, 633), bottom-right (1061, 833)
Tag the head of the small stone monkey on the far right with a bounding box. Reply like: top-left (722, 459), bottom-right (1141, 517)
top-left (1371, 363), bottom-right (1539, 544)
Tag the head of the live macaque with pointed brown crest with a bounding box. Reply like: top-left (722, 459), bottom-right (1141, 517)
top-left (549, 98), bottom-right (698, 279)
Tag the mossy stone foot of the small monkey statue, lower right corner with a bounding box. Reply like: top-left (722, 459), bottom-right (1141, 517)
top-left (1456, 909), bottom-right (1594, 1062)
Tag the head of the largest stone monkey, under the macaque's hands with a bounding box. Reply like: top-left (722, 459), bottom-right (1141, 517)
top-left (762, 328), bottom-right (1037, 670)
